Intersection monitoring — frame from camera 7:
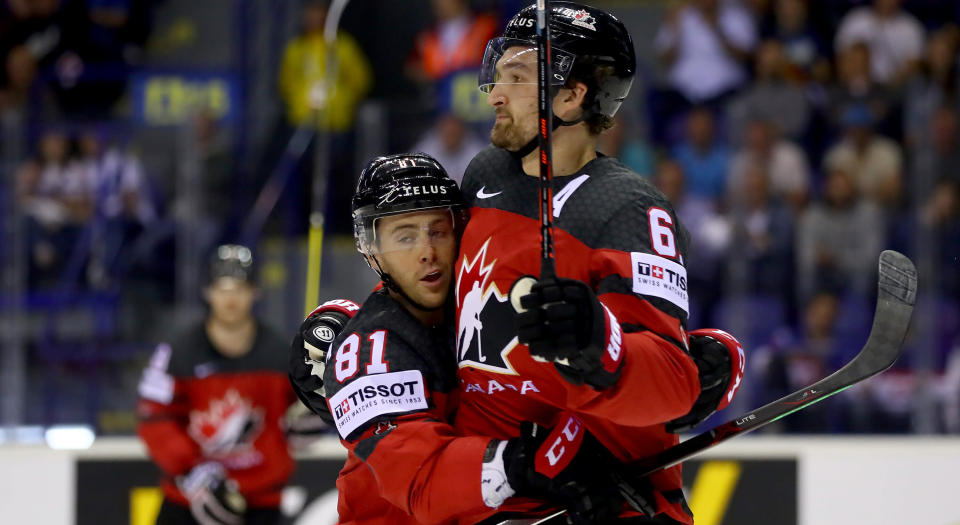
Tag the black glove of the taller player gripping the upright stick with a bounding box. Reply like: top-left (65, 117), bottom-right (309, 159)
top-left (511, 278), bottom-right (624, 389)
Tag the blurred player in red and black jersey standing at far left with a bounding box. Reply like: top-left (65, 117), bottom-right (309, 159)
top-left (137, 245), bottom-right (316, 525)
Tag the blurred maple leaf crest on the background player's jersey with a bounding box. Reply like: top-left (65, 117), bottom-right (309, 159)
top-left (187, 388), bottom-right (263, 458)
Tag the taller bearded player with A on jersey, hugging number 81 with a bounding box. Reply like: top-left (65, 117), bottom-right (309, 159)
top-left (455, 1), bottom-right (741, 524)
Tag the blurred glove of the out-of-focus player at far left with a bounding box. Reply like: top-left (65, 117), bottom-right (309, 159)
top-left (177, 461), bottom-right (247, 525)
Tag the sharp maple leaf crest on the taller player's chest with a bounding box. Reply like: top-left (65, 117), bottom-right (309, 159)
top-left (456, 239), bottom-right (518, 375)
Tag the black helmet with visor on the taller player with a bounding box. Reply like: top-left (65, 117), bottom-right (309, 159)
top-left (479, 1), bottom-right (637, 118)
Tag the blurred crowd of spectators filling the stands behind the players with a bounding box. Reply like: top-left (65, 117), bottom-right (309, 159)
top-left (0, 0), bottom-right (960, 432)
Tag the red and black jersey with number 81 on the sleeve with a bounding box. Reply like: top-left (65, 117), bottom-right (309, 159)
top-left (324, 291), bottom-right (490, 525)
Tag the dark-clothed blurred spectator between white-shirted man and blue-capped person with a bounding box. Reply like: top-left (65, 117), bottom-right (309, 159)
top-left (827, 42), bottom-right (898, 136)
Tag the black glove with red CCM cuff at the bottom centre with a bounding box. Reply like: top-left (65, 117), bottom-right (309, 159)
top-left (483, 415), bottom-right (624, 524)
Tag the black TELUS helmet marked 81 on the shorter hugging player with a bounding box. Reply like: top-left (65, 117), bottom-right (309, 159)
top-left (352, 153), bottom-right (468, 285)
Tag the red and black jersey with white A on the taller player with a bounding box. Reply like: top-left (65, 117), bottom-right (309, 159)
top-left (455, 147), bottom-right (700, 523)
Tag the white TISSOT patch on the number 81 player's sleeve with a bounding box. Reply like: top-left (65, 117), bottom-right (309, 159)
top-left (328, 370), bottom-right (427, 439)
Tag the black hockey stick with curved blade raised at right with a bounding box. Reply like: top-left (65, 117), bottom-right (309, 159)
top-left (501, 250), bottom-right (917, 525)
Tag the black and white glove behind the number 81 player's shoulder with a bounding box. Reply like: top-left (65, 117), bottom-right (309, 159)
top-left (288, 299), bottom-right (360, 425)
